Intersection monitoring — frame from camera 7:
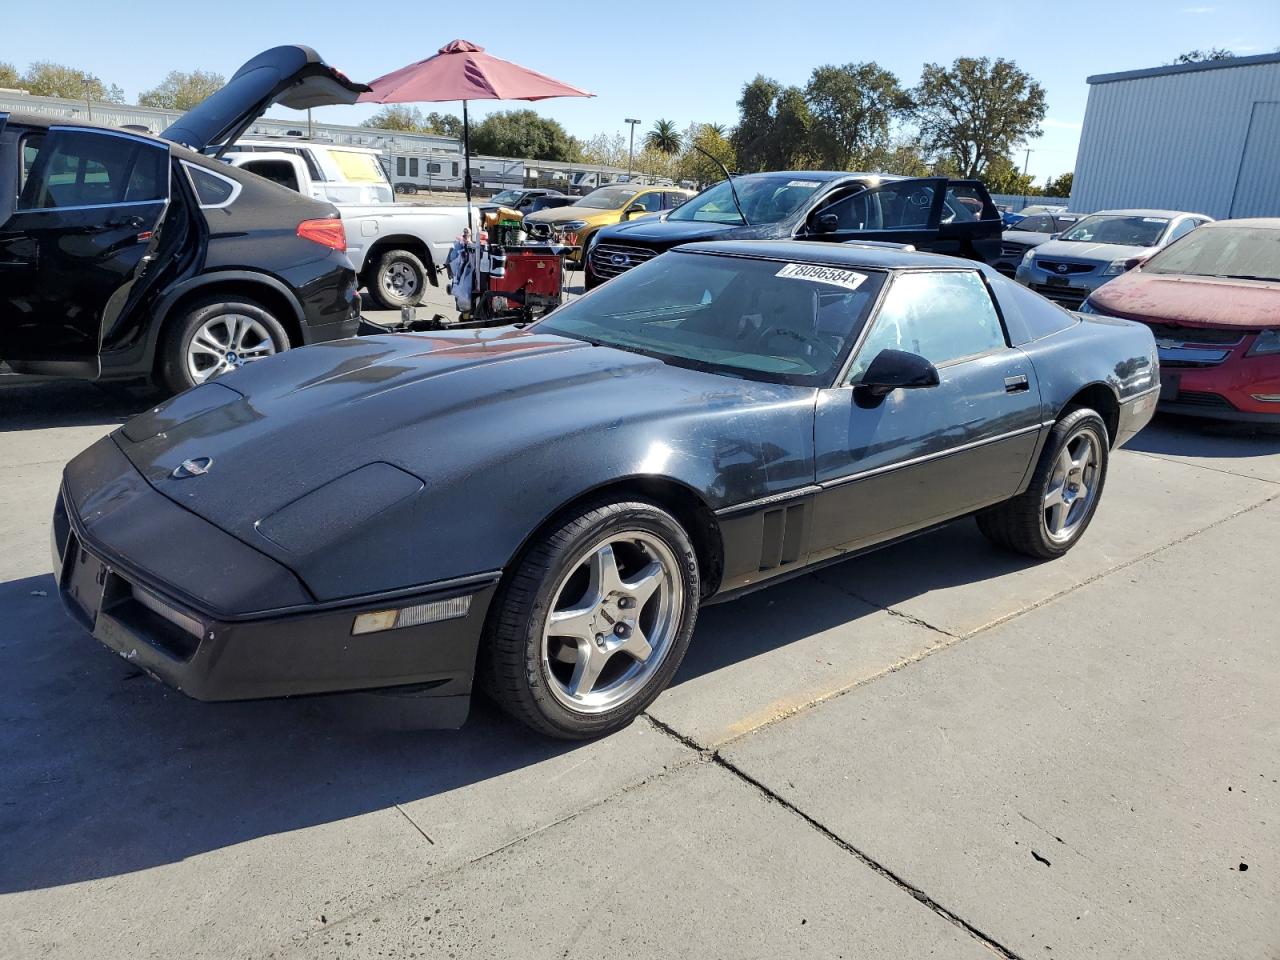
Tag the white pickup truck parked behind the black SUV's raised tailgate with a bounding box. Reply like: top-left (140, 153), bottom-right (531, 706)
top-left (223, 141), bottom-right (467, 310)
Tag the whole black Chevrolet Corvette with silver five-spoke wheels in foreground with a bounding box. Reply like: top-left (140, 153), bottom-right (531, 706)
top-left (54, 241), bottom-right (1158, 737)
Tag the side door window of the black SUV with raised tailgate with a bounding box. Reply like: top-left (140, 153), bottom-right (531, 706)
top-left (18, 129), bottom-right (169, 210)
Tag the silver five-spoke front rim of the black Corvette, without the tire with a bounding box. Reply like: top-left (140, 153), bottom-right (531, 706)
top-left (541, 530), bottom-right (684, 713)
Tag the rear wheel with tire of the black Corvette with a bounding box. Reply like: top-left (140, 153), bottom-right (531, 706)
top-left (978, 407), bottom-right (1110, 559)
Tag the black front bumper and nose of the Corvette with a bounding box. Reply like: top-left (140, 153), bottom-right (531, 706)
top-left (52, 438), bottom-right (498, 726)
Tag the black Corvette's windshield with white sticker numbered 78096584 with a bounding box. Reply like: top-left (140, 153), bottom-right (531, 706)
top-left (538, 252), bottom-right (884, 387)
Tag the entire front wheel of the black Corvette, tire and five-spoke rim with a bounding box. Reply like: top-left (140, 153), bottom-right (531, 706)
top-left (481, 500), bottom-right (701, 740)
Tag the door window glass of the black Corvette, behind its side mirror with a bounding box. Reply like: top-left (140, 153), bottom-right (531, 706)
top-left (849, 270), bottom-right (1005, 383)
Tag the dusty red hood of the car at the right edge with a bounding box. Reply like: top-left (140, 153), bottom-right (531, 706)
top-left (1089, 270), bottom-right (1280, 329)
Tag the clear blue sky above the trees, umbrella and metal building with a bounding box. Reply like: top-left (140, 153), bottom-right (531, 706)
top-left (0, 0), bottom-right (1280, 179)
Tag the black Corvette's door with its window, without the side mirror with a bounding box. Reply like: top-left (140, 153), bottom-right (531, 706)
top-left (813, 270), bottom-right (1042, 559)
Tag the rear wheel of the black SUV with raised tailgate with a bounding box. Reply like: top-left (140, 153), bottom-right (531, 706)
top-left (159, 294), bottom-right (289, 393)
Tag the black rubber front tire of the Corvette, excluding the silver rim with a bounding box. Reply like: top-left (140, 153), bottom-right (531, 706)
top-left (506, 502), bottom-right (700, 736)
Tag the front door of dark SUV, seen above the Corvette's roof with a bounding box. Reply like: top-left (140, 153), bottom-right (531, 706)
top-left (797, 177), bottom-right (946, 247)
